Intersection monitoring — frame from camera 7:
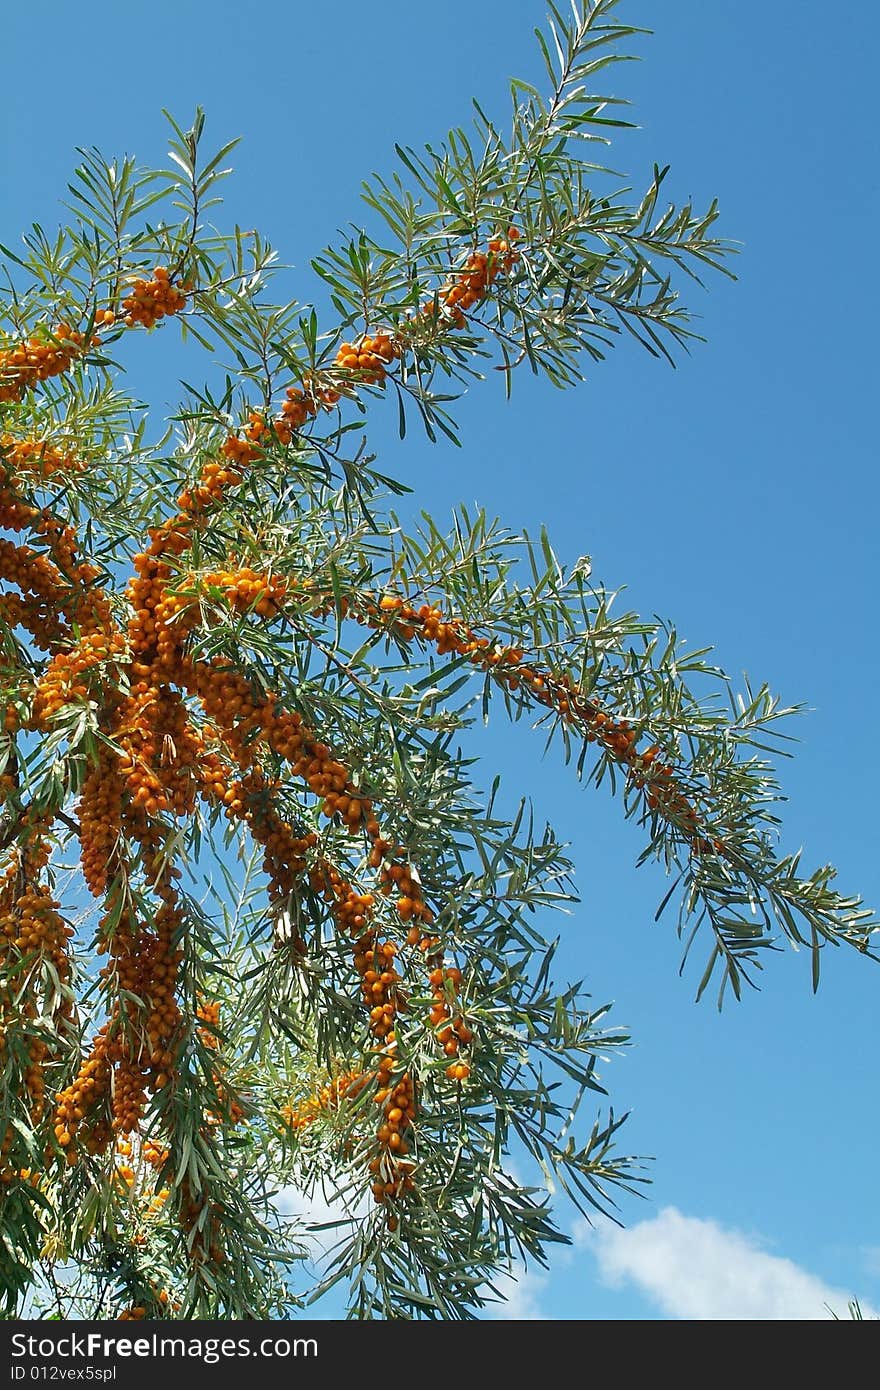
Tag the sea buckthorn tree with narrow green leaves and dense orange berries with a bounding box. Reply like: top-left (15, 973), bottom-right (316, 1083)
top-left (0, 0), bottom-right (876, 1319)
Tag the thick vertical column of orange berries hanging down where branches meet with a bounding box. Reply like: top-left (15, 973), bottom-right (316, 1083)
top-left (43, 505), bottom-right (255, 1155)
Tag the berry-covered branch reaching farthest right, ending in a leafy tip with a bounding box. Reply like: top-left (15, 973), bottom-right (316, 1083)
top-left (352, 595), bottom-right (873, 998)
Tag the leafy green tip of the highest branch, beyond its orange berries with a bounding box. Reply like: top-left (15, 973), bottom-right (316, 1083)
top-left (325, 0), bottom-right (731, 414)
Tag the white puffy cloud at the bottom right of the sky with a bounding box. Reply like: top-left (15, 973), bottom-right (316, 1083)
top-left (576, 1207), bottom-right (877, 1322)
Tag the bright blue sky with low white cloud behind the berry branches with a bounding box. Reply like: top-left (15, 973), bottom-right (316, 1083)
top-left (0, 0), bottom-right (880, 1319)
